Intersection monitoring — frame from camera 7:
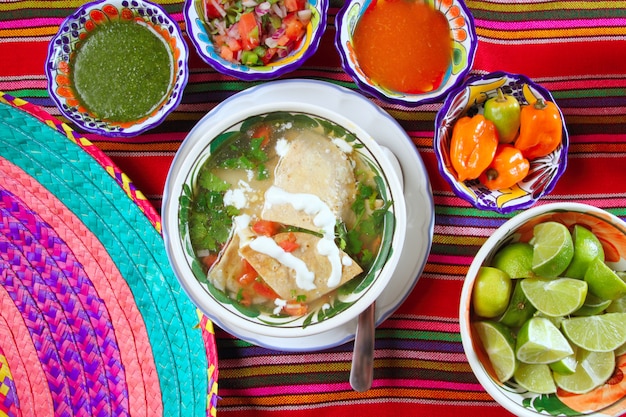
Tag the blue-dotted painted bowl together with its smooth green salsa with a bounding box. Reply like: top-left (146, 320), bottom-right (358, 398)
top-left (45, 0), bottom-right (189, 137)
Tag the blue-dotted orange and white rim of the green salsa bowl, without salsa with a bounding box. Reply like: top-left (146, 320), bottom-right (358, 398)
top-left (45, 0), bottom-right (189, 137)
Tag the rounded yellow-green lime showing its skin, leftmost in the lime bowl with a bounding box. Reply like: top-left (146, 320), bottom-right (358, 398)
top-left (472, 266), bottom-right (512, 318)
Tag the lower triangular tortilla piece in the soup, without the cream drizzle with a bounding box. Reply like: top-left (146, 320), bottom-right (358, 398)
top-left (239, 232), bottom-right (363, 303)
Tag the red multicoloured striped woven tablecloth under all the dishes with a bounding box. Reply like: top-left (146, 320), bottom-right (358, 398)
top-left (0, 0), bottom-right (626, 417)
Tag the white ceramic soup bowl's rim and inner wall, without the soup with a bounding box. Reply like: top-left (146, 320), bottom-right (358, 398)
top-left (162, 80), bottom-right (406, 340)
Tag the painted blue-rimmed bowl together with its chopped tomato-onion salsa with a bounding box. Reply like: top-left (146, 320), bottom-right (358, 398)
top-left (183, 0), bottom-right (328, 81)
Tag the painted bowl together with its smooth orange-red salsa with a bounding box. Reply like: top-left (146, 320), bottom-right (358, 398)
top-left (335, 0), bottom-right (478, 107)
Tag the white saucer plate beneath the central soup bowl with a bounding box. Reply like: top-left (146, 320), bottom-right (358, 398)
top-left (166, 79), bottom-right (434, 352)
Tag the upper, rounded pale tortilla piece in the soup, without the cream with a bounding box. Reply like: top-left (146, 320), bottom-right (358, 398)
top-left (261, 132), bottom-right (356, 231)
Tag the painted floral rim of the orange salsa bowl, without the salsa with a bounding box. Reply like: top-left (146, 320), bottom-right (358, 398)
top-left (335, 0), bottom-right (478, 106)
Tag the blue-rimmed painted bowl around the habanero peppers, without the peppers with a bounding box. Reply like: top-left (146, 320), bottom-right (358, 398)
top-left (433, 72), bottom-right (569, 214)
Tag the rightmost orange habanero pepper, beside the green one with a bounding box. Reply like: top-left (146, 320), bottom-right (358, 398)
top-left (515, 98), bottom-right (563, 160)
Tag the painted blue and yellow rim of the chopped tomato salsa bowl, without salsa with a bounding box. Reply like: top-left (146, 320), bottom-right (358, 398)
top-left (183, 0), bottom-right (328, 81)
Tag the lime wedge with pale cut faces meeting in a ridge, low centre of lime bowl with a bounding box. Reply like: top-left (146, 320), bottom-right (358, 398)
top-left (515, 317), bottom-right (574, 364)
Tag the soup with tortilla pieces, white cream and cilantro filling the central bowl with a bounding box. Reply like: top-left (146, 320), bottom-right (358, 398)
top-left (183, 112), bottom-right (392, 316)
